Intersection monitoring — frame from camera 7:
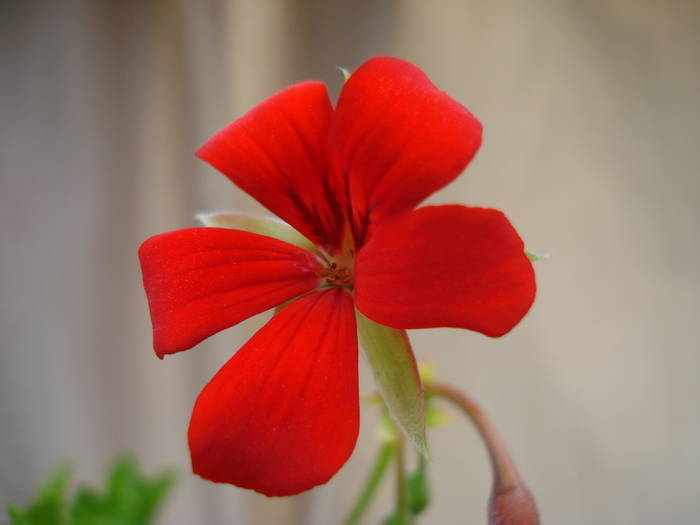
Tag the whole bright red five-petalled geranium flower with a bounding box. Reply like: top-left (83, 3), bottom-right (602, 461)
top-left (139, 58), bottom-right (535, 496)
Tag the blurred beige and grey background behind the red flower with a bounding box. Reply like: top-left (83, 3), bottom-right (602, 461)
top-left (0, 0), bottom-right (700, 525)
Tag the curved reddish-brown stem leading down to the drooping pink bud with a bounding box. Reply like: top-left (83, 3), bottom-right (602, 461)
top-left (425, 382), bottom-right (520, 491)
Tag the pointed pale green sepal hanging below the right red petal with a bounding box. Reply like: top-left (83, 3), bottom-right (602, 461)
top-left (356, 311), bottom-right (428, 458)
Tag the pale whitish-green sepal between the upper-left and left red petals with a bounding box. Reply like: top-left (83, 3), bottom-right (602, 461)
top-left (196, 212), bottom-right (318, 254)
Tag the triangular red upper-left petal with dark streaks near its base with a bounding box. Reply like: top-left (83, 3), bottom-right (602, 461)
top-left (197, 82), bottom-right (343, 252)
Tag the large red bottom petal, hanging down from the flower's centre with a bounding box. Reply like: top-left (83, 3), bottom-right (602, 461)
top-left (189, 288), bottom-right (359, 496)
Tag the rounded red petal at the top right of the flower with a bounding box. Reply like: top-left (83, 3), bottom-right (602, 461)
top-left (330, 58), bottom-right (481, 244)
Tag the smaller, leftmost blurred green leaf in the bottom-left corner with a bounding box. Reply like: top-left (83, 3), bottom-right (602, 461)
top-left (7, 465), bottom-right (71, 525)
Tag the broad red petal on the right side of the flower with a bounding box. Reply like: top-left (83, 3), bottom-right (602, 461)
top-left (355, 206), bottom-right (535, 337)
